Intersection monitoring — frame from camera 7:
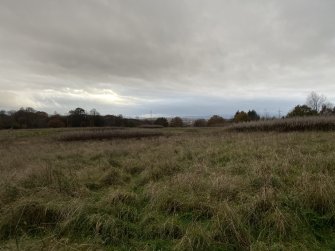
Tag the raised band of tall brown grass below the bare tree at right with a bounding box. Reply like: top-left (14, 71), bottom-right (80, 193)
top-left (226, 116), bottom-right (335, 132)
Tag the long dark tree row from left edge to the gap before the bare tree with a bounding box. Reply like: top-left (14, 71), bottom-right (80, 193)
top-left (0, 107), bottom-right (259, 129)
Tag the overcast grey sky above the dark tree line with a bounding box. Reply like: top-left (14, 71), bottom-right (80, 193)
top-left (0, 0), bottom-right (335, 116)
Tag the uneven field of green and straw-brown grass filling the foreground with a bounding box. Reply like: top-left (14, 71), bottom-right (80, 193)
top-left (0, 128), bottom-right (335, 250)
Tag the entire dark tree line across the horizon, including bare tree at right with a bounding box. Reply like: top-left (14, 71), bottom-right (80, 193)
top-left (0, 92), bottom-right (335, 129)
